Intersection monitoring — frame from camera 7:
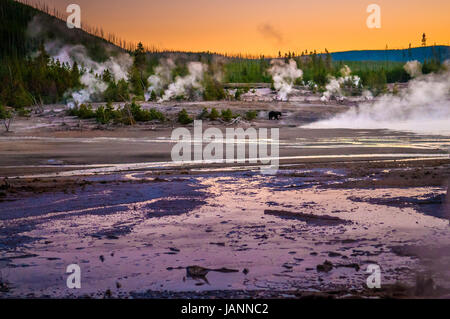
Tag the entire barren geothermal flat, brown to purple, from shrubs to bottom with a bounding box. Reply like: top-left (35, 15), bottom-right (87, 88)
top-left (0, 102), bottom-right (450, 298)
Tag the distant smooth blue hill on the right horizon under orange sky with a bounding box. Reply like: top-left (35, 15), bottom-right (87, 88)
top-left (331, 45), bottom-right (450, 62)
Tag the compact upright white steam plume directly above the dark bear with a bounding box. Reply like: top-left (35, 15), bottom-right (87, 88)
top-left (269, 59), bottom-right (303, 101)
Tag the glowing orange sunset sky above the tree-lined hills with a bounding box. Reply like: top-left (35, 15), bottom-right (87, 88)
top-left (39, 0), bottom-right (450, 55)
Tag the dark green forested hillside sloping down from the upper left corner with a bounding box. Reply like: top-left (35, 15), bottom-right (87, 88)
top-left (0, 0), bottom-right (128, 107)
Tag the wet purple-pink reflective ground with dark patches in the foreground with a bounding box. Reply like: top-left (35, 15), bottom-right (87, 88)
top-left (0, 169), bottom-right (450, 297)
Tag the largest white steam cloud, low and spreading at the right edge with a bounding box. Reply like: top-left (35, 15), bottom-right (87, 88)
top-left (305, 63), bottom-right (450, 134)
